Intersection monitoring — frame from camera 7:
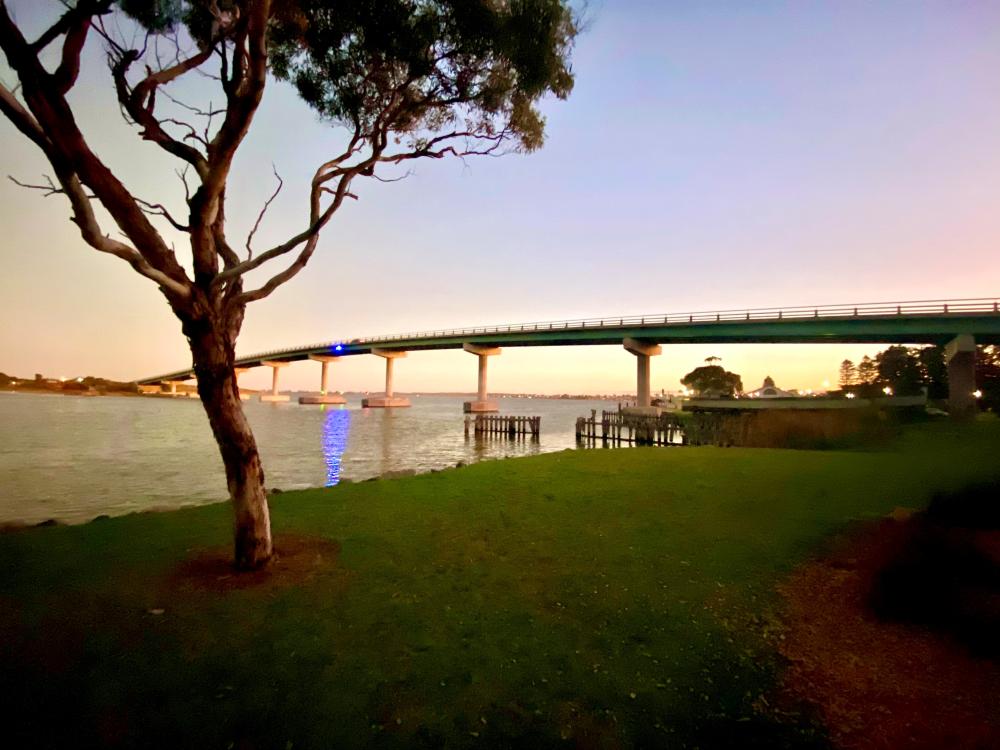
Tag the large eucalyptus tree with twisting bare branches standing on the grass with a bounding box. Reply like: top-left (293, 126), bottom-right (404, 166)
top-left (0, 0), bottom-right (577, 568)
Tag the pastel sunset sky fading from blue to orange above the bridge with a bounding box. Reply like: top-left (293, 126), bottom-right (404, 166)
top-left (0, 0), bottom-right (1000, 393)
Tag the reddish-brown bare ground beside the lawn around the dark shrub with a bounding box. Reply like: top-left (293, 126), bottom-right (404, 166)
top-left (779, 514), bottom-right (1000, 750)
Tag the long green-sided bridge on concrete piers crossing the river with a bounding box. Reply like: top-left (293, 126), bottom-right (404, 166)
top-left (138, 298), bottom-right (1000, 414)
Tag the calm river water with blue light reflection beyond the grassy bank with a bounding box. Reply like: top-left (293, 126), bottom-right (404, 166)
top-left (0, 393), bottom-right (617, 523)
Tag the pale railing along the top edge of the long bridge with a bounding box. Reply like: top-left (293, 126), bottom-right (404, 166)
top-left (146, 297), bottom-right (1000, 382)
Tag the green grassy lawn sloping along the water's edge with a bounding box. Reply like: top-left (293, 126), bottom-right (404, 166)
top-left (0, 422), bottom-right (1000, 748)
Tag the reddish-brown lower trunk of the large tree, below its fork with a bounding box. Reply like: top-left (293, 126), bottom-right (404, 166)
top-left (185, 323), bottom-right (272, 570)
